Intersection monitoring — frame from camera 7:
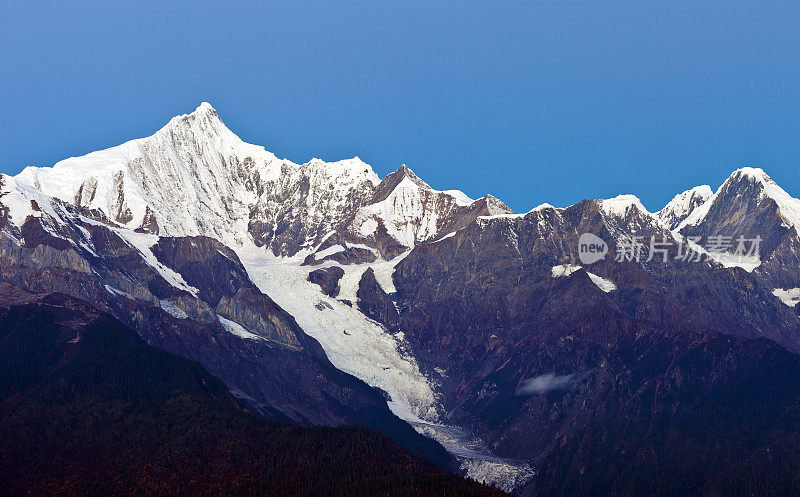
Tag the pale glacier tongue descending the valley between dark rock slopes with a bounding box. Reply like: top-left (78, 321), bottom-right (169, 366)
top-left (237, 245), bottom-right (536, 491)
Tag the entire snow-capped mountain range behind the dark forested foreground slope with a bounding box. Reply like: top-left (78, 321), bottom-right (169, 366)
top-left (0, 103), bottom-right (800, 495)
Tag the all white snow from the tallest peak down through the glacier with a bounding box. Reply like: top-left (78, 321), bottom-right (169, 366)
top-left (9, 103), bottom-right (528, 488)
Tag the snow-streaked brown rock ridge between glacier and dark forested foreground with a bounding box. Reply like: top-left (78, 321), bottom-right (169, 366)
top-left (0, 170), bottom-right (450, 466)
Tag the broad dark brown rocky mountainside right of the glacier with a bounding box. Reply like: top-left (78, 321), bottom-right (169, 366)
top-left (394, 201), bottom-right (800, 495)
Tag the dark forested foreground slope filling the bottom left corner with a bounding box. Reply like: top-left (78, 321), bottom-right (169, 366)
top-left (0, 284), bottom-right (501, 496)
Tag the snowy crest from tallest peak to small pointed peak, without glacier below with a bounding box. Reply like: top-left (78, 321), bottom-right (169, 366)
top-left (16, 103), bottom-right (509, 255)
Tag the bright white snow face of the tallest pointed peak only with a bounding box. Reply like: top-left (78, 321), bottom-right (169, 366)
top-left (17, 103), bottom-right (266, 243)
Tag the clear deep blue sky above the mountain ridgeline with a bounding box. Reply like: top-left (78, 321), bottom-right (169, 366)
top-left (0, 0), bottom-right (800, 211)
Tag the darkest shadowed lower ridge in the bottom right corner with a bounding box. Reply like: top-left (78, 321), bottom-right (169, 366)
top-left (527, 330), bottom-right (800, 496)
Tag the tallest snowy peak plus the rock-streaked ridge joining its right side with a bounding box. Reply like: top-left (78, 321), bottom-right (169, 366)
top-left (17, 103), bottom-right (379, 252)
